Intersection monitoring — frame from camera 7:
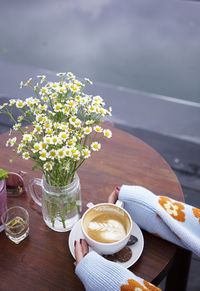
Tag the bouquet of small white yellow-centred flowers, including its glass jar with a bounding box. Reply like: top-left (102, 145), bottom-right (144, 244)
top-left (0, 73), bottom-right (112, 231)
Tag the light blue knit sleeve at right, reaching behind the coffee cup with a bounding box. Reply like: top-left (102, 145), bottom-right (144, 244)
top-left (119, 185), bottom-right (200, 256)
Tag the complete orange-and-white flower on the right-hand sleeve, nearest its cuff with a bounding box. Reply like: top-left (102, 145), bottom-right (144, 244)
top-left (158, 196), bottom-right (185, 222)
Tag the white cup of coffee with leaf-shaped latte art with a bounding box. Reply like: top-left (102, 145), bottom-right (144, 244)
top-left (81, 201), bottom-right (132, 255)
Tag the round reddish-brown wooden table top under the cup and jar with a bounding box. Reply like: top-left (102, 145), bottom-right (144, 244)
top-left (0, 126), bottom-right (184, 291)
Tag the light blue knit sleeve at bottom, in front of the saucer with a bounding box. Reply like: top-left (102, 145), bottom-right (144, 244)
top-left (75, 251), bottom-right (160, 291)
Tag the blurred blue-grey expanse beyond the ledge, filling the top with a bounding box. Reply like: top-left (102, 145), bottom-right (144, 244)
top-left (0, 0), bottom-right (200, 102)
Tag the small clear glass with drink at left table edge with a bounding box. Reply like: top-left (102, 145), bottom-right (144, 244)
top-left (1, 206), bottom-right (29, 244)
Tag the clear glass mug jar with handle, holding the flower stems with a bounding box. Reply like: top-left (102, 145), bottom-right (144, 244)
top-left (28, 173), bottom-right (81, 232)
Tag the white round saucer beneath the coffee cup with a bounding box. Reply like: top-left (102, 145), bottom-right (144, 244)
top-left (68, 219), bottom-right (144, 268)
